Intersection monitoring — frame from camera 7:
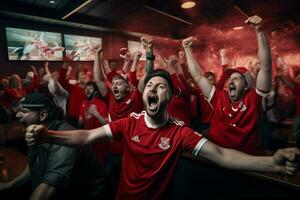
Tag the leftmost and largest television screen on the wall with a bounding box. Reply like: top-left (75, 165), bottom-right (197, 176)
top-left (6, 27), bottom-right (64, 61)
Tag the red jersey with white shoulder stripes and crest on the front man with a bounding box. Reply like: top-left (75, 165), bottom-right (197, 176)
top-left (104, 111), bottom-right (207, 200)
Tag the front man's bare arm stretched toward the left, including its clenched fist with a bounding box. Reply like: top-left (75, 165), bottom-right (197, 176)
top-left (25, 125), bottom-right (108, 146)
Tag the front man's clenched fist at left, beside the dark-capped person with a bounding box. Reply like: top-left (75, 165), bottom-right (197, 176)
top-left (25, 124), bottom-right (48, 146)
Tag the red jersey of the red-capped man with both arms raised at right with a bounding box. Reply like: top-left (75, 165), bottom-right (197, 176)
top-left (208, 87), bottom-right (267, 155)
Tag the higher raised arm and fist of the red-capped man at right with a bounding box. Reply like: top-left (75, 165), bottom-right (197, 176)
top-left (245, 15), bottom-right (272, 92)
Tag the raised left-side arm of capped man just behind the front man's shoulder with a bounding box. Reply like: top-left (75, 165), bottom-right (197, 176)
top-left (93, 47), bottom-right (108, 96)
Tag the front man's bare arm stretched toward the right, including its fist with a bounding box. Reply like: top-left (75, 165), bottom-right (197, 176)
top-left (198, 141), bottom-right (300, 175)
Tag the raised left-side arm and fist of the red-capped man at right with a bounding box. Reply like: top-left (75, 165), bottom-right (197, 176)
top-left (182, 37), bottom-right (213, 97)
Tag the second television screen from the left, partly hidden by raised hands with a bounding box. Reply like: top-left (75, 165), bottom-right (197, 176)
top-left (64, 35), bottom-right (102, 61)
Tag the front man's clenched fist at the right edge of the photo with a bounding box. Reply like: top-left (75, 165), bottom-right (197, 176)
top-left (273, 148), bottom-right (300, 175)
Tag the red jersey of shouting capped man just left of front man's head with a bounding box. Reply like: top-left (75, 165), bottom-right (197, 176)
top-left (106, 90), bottom-right (143, 154)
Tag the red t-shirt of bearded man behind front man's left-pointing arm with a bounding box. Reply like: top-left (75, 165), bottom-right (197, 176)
top-left (80, 98), bottom-right (108, 164)
